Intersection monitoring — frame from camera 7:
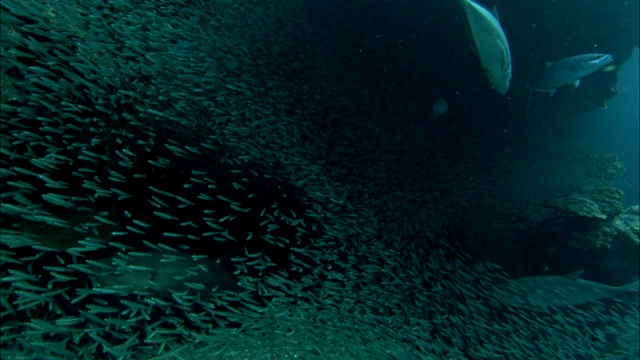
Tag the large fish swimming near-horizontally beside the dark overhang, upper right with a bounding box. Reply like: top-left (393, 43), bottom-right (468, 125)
top-left (529, 54), bottom-right (613, 104)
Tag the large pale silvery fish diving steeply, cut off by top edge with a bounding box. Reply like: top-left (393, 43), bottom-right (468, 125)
top-left (458, 0), bottom-right (511, 95)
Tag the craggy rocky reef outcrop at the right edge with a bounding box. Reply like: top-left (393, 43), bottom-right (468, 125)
top-left (532, 185), bottom-right (640, 284)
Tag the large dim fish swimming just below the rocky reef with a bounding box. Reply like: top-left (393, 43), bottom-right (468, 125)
top-left (494, 271), bottom-right (640, 307)
